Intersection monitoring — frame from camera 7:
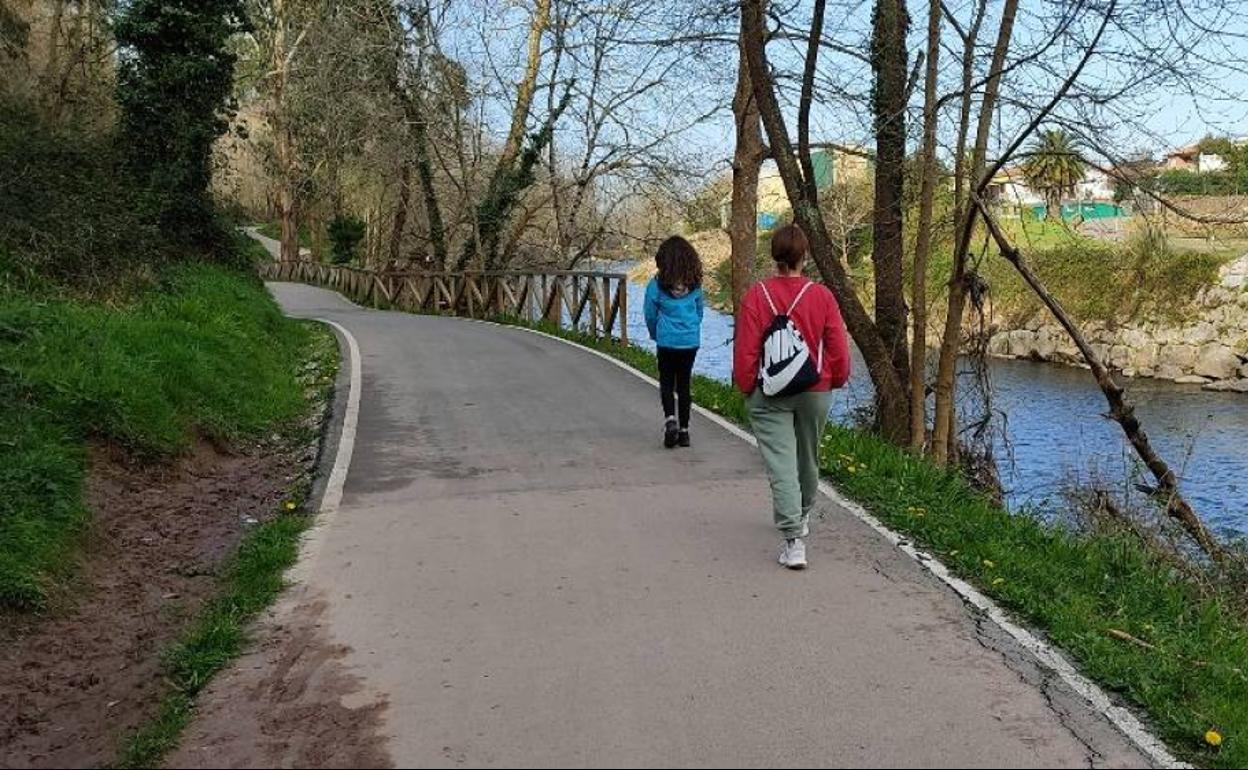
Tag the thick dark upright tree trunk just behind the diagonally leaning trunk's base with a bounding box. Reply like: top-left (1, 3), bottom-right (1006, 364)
top-left (871, 0), bottom-right (910, 386)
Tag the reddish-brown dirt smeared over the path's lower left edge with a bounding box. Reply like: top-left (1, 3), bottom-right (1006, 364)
top-left (167, 589), bottom-right (392, 768)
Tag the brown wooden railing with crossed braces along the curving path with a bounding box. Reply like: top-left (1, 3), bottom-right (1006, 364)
top-left (260, 261), bottom-right (628, 342)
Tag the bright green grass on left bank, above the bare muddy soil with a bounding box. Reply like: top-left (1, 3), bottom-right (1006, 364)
top-left (0, 266), bottom-right (311, 612)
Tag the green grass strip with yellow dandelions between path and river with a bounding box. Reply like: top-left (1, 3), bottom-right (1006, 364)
top-left (509, 315), bottom-right (1248, 768)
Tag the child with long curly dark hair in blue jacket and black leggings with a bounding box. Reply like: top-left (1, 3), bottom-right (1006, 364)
top-left (645, 236), bottom-right (703, 449)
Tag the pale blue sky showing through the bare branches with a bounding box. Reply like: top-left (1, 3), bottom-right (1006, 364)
top-left (447, 0), bottom-right (1248, 178)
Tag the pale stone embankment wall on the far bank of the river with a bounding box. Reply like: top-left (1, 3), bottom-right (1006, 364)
top-left (988, 255), bottom-right (1248, 393)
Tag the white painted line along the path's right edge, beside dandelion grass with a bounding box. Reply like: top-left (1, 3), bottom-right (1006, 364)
top-left (501, 322), bottom-right (1192, 768)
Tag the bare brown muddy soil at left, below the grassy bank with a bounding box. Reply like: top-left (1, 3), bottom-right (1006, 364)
top-left (0, 443), bottom-right (305, 768)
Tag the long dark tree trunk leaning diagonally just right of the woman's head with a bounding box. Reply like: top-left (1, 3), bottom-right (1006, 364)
top-left (741, 0), bottom-right (910, 446)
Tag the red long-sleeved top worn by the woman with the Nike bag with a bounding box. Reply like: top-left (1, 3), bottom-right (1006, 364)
top-left (733, 276), bottom-right (850, 393)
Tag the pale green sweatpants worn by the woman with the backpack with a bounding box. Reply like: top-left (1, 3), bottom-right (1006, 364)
top-left (746, 389), bottom-right (832, 538)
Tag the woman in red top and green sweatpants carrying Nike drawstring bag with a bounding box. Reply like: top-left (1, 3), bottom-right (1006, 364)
top-left (733, 225), bottom-right (850, 569)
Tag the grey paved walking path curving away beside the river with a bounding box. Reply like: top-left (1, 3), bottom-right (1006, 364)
top-left (165, 279), bottom-right (1146, 768)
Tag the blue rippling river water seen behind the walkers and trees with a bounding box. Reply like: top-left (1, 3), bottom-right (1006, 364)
top-left (616, 274), bottom-right (1248, 535)
